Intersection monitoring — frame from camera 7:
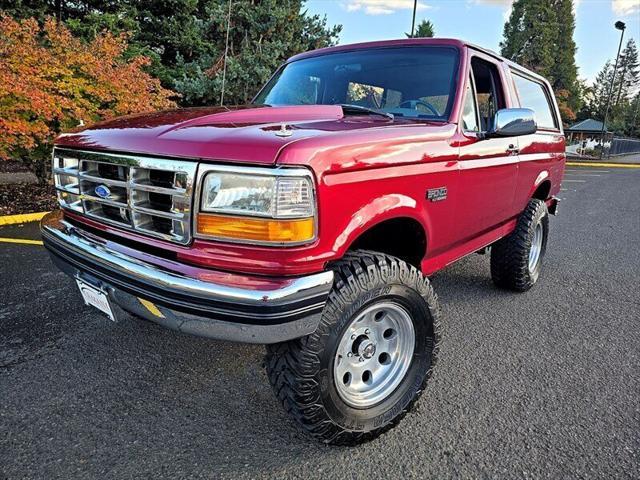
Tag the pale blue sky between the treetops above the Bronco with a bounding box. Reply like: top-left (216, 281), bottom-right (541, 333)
top-left (306, 0), bottom-right (640, 82)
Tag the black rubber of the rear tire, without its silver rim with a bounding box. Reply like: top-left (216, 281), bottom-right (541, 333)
top-left (491, 199), bottom-right (549, 292)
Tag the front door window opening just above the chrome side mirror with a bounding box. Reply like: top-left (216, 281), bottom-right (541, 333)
top-left (471, 58), bottom-right (504, 132)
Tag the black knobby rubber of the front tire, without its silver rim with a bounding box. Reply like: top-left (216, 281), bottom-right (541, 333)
top-left (266, 250), bottom-right (440, 445)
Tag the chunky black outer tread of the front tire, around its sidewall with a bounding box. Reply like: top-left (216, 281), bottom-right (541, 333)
top-left (265, 250), bottom-right (441, 445)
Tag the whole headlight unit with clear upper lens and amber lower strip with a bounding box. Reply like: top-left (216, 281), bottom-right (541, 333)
top-left (196, 168), bottom-right (316, 245)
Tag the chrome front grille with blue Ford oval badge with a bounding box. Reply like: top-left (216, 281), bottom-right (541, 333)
top-left (53, 149), bottom-right (197, 244)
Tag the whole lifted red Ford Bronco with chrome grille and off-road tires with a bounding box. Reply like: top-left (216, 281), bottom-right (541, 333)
top-left (41, 39), bottom-right (565, 444)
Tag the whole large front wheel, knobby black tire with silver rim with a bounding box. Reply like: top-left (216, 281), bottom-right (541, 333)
top-left (266, 251), bottom-right (440, 445)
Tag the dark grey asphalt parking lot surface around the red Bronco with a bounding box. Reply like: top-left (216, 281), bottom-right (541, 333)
top-left (0, 167), bottom-right (640, 479)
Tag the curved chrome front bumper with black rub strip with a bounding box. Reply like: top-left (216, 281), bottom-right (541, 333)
top-left (40, 211), bottom-right (333, 344)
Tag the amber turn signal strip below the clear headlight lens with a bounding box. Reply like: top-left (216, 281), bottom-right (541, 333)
top-left (197, 213), bottom-right (315, 243)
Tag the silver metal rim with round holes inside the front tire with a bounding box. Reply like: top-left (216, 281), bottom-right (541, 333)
top-left (333, 301), bottom-right (415, 408)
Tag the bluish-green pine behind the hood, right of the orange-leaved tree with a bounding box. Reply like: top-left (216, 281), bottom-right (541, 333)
top-left (174, 0), bottom-right (341, 105)
